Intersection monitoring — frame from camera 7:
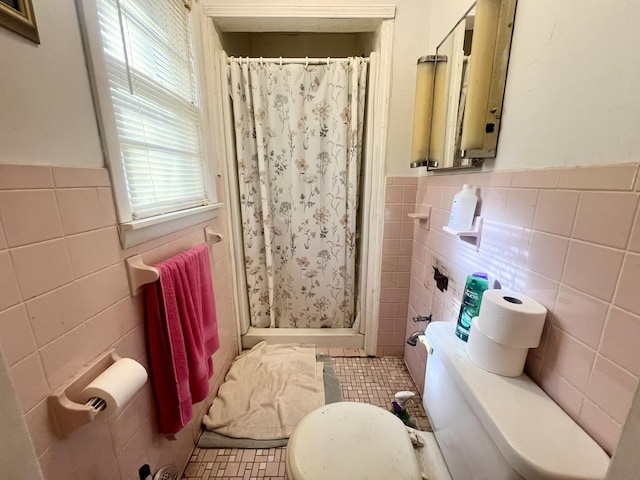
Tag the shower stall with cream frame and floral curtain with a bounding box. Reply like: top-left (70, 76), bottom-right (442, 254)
top-left (205, 6), bottom-right (393, 354)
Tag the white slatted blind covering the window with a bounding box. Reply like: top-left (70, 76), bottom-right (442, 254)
top-left (97, 0), bottom-right (209, 220)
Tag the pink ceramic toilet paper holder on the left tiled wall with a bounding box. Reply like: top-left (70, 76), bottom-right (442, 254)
top-left (48, 349), bottom-right (130, 438)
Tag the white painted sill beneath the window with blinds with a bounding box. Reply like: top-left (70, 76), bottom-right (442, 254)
top-left (118, 203), bottom-right (222, 249)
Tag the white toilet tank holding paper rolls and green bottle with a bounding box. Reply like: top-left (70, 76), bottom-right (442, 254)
top-left (423, 322), bottom-right (609, 480)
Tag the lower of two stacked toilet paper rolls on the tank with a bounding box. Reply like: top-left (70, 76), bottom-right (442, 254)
top-left (467, 318), bottom-right (529, 377)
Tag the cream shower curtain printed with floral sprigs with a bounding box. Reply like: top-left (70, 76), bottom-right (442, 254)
top-left (230, 57), bottom-right (367, 328)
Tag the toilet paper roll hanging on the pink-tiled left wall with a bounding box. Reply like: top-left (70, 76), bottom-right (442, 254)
top-left (80, 358), bottom-right (147, 415)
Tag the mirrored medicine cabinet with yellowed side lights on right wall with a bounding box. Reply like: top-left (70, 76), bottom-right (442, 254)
top-left (411, 0), bottom-right (516, 170)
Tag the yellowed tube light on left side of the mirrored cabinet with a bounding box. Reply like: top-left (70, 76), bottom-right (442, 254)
top-left (410, 55), bottom-right (446, 168)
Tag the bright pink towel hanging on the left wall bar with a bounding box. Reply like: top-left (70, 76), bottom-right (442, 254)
top-left (146, 244), bottom-right (220, 434)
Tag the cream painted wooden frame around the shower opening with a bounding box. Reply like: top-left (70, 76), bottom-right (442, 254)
top-left (203, 1), bottom-right (395, 355)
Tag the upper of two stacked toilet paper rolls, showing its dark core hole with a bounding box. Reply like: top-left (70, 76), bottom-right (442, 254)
top-left (478, 290), bottom-right (547, 348)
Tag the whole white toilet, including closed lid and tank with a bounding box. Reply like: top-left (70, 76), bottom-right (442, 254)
top-left (285, 322), bottom-right (609, 480)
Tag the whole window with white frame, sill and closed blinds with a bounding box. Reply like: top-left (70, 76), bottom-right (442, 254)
top-left (79, 0), bottom-right (217, 247)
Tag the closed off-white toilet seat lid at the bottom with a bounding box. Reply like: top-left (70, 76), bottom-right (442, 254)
top-left (285, 402), bottom-right (421, 480)
